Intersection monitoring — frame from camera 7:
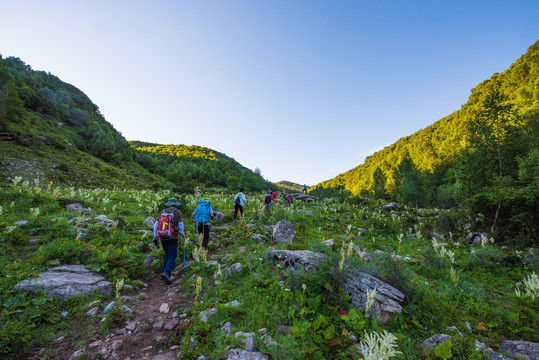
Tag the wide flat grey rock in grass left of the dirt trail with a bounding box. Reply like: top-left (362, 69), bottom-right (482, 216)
top-left (13, 265), bottom-right (112, 300)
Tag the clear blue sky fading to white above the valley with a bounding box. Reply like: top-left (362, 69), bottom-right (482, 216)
top-left (0, 0), bottom-right (539, 185)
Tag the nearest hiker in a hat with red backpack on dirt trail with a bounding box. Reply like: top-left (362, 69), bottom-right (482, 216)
top-left (153, 198), bottom-right (185, 285)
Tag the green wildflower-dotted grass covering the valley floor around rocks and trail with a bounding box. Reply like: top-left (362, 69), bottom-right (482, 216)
top-left (0, 181), bottom-right (539, 359)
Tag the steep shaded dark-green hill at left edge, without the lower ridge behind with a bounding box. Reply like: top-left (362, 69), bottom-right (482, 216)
top-left (0, 57), bottom-right (162, 187)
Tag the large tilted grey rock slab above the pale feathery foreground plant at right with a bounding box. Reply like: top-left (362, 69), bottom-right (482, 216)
top-left (342, 269), bottom-right (404, 324)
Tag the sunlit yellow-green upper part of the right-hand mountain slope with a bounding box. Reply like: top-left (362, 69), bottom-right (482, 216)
top-left (315, 41), bottom-right (539, 195)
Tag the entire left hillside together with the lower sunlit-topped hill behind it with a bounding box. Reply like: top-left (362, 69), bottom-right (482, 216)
top-left (0, 56), bottom-right (265, 192)
